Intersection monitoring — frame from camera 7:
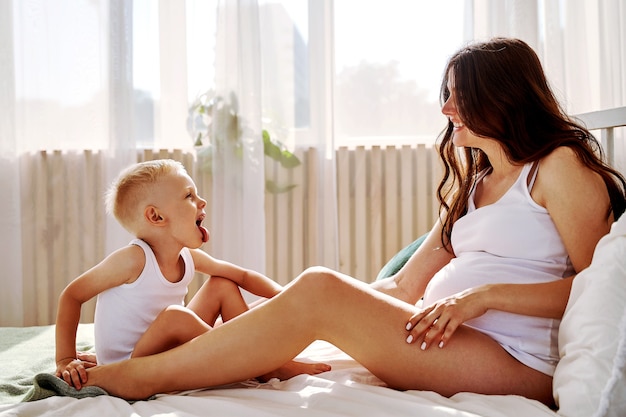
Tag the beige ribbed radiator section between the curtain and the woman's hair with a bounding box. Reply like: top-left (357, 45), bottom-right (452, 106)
top-left (336, 145), bottom-right (440, 282)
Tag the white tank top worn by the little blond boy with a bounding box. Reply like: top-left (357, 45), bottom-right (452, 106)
top-left (94, 239), bottom-right (195, 364)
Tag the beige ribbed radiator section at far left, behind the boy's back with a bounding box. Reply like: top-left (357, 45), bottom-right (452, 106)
top-left (20, 151), bottom-right (105, 326)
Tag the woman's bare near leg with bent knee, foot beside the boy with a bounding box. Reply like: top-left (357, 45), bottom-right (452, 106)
top-left (88, 268), bottom-right (552, 404)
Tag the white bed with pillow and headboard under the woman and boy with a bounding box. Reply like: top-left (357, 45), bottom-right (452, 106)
top-left (0, 107), bottom-right (626, 417)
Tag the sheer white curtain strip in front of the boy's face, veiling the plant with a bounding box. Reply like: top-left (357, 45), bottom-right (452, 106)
top-left (209, 0), bottom-right (265, 272)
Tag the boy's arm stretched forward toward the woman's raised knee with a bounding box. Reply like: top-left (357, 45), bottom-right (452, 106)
top-left (191, 249), bottom-right (283, 298)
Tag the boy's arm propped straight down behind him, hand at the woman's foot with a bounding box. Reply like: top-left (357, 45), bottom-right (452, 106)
top-left (55, 245), bottom-right (145, 388)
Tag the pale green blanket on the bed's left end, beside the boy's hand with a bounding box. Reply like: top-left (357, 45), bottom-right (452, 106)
top-left (0, 324), bottom-right (93, 404)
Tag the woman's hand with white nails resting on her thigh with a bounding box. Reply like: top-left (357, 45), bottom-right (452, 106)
top-left (406, 285), bottom-right (489, 350)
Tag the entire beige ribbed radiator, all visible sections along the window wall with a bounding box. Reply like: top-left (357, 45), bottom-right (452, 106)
top-left (20, 145), bottom-right (440, 325)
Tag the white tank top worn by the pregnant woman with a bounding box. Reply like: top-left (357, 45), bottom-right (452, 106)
top-left (424, 164), bottom-right (574, 375)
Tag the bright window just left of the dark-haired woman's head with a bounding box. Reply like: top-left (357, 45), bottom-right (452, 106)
top-left (333, 0), bottom-right (465, 145)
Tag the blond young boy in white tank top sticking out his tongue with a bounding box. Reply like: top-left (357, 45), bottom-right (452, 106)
top-left (56, 160), bottom-right (330, 389)
